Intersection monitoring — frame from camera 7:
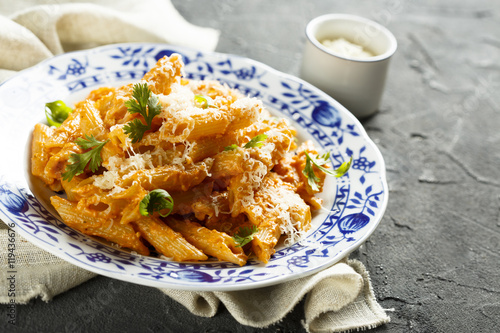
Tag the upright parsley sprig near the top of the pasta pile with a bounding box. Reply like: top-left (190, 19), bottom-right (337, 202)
top-left (123, 83), bottom-right (161, 143)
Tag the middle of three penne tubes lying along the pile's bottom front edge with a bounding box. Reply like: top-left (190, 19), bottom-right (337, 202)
top-left (133, 217), bottom-right (208, 261)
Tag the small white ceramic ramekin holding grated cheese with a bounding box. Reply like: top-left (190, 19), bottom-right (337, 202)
top-left (300, 14), bottom-right (397, 118)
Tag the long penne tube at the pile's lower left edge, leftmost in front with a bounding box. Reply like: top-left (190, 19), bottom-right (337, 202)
top-left (50, 196), bottom-right (149, 255)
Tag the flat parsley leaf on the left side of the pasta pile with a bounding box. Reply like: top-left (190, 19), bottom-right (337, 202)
top-left (62, 135), bottom-right (109, 181)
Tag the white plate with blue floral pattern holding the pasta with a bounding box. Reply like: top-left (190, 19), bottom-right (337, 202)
top-left (0, 44), bottom-right (388, 290)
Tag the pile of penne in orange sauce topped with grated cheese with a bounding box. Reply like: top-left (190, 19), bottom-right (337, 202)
top-left (32, 54), bottom-right (325, 265)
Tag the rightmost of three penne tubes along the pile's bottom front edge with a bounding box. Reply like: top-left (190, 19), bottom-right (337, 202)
top-left (166, 217), bottom-right (247, 266)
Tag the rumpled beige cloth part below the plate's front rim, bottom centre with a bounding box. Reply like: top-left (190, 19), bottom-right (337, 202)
top-left (160, 260), bottom-right (390, 333)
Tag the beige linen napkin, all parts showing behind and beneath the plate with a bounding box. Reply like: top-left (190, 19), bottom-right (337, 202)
top-left (0, 0), bottom-right (390, 332)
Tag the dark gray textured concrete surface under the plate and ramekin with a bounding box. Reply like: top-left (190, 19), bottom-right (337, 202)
top-left (0, 0), bottom-right (500, 333)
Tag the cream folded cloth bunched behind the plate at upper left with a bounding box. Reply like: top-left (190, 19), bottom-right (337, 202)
top-left (0, 0), bottom-right (219, 81)
